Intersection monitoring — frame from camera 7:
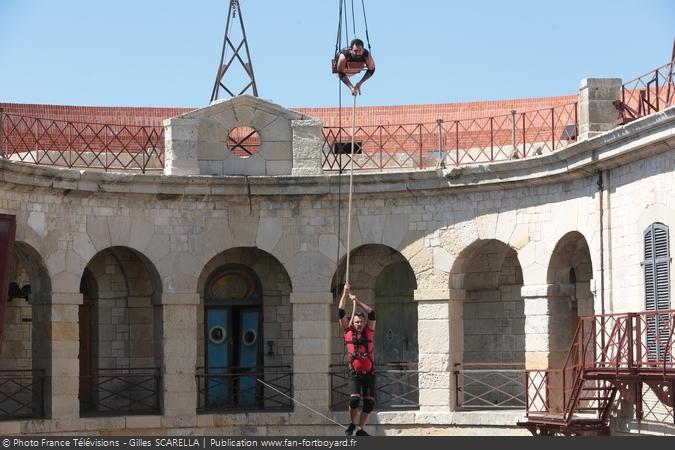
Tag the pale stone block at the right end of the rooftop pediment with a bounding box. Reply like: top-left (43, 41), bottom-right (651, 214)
top-left (291, 119), bottom-right (324, 175)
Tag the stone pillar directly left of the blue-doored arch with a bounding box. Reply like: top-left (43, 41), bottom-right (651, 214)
top-left (159, 294), bottom-right (199, 427)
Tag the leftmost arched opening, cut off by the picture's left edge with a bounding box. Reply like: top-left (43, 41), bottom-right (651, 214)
top-left (0, 242), bottom-right (51, 419)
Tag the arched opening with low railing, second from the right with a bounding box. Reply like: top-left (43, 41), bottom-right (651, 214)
top-left (450, 239), bottom-right (525, 408)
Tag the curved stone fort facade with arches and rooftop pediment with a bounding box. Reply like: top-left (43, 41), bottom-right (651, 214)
top-left (0, 84), bottom-right (675, 435)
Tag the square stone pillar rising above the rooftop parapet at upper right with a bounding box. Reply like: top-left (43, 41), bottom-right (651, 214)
top-left (578, 78), bottom-right (621, 141)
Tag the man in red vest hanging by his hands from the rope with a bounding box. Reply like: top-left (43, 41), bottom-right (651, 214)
top-left (338, 284), bottom-right (375, 436)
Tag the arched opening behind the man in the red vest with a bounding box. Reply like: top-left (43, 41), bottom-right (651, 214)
top-left (331, 244), bottom-right (419, 409)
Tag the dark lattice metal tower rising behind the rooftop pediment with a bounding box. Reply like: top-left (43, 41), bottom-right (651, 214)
top-left (211, 0), bottom-right (258, 101)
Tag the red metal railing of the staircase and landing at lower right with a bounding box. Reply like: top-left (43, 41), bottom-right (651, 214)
top-left (526, 310), bottom-right (675, 422)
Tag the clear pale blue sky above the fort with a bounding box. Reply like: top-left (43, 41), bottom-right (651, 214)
top-left (0, 0), bottom-right (675, 107)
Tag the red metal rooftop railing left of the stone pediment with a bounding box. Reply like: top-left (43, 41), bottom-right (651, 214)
top-left (0, 112), bottom-right (164, 173)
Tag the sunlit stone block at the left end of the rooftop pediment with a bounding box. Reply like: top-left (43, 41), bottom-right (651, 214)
top-left (164, 118), bottom-right (201, 175)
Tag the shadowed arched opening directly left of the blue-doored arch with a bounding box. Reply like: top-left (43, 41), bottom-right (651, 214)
top-left (78, 247), bottom-right (161, 416)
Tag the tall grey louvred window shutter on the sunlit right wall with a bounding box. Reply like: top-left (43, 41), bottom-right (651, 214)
top-left (644, 223), bottom-right (670, 361)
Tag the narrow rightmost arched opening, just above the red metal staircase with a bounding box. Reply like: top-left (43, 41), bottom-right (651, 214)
top-left (546, 231), bottom-right (594, 368)
